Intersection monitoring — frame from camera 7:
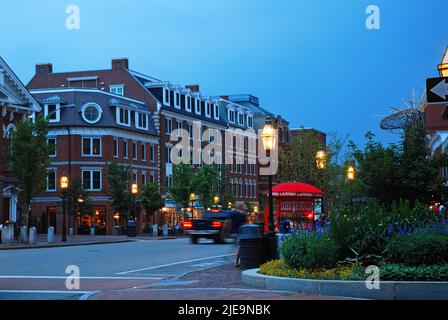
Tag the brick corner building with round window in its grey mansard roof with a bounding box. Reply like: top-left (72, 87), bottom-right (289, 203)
top-left (31, 87), bottom-right (159, 234)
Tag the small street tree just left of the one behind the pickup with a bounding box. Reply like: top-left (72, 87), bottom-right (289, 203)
top-left (169, 163), bottom-right (194, 208)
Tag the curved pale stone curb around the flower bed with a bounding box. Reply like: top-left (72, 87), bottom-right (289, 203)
top-left (242, 269), bottom-right (448, 300)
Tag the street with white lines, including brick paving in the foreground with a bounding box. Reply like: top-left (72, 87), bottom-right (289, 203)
top-left (0, 238), bottom-right (346, 300)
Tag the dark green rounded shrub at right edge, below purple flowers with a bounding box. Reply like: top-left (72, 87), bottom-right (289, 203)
top-left (384, 230), bottom-right (448, 266)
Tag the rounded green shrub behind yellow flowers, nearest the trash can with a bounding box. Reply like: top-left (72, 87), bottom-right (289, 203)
top-left (281, 233), bottom-right (338, 269)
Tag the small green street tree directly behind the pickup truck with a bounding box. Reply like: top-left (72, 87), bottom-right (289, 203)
top-left (193, 165), bottom-right (219, 209)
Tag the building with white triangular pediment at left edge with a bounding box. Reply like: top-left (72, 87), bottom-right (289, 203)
top-left (0, 58), bottom-right (41, 224)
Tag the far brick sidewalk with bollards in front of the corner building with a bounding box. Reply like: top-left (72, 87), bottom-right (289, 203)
top-left (0, 235), bottom-right (186, 250)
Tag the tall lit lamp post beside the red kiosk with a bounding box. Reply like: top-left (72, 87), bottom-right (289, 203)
top-left (261, 120), bottom-right (277, 260)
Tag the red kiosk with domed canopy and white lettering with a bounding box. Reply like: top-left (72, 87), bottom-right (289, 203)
top-left (264, 182), bottom-right (324, 232)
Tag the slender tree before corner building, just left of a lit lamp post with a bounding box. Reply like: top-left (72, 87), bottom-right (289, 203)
top-left (107, 161), bottom-right (132, 223)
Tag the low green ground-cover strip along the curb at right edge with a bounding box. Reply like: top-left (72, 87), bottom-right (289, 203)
top-left (380, 264), bottom-right (448, 281)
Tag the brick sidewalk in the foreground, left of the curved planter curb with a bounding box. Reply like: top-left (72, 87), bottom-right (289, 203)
top-left (90, 264), bottom-right (345, 300)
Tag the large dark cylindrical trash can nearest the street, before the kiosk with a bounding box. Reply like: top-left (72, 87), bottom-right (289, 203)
top-left (240, 225), bottom-right (267, 270)
